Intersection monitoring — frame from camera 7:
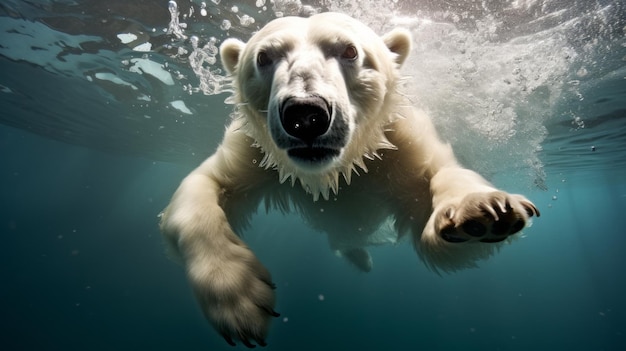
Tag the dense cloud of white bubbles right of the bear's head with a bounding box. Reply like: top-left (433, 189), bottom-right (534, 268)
top-left (398, 17), bottom-right (573, 188)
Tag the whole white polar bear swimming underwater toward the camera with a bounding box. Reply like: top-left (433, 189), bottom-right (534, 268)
top-left (161, 13), bottom-right (539, 347)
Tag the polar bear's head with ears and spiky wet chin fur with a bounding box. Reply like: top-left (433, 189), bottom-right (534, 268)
top-left (220, 13), bottom-right (411, 197)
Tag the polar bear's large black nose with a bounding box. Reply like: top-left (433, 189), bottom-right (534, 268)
top-left (280, 96), bottom-right (330, 145)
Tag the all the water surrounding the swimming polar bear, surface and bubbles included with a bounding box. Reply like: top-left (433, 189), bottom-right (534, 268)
top-left (0, 0), bottom-right (626, 350)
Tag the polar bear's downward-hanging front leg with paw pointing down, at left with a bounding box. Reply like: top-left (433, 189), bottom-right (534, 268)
top-left (161, 170), bottom-right (278, 347)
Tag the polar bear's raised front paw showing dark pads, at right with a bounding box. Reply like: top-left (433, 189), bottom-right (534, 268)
top-left (416, 167), bottom-right (540, 270)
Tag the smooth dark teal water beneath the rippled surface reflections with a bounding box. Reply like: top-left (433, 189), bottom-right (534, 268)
top-left (0, 127), bottom-right (626, 350)
